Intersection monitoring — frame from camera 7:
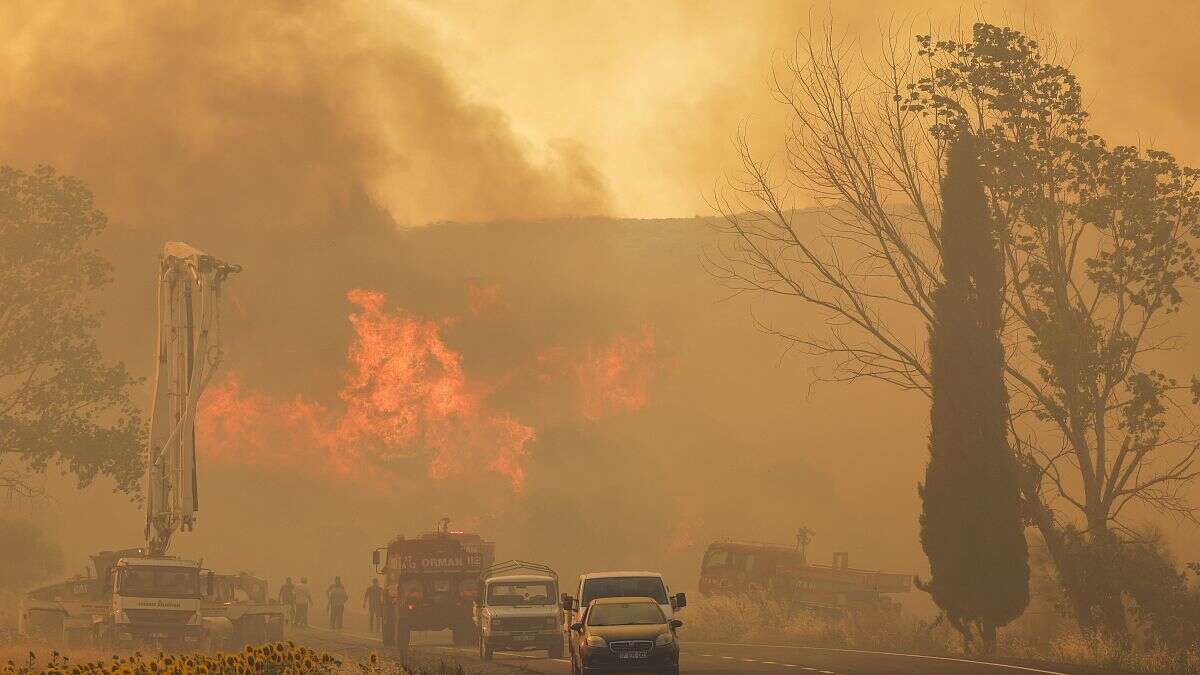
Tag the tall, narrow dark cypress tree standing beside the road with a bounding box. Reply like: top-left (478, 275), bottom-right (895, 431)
top-left (918, 131), bottom-right (1030, 651)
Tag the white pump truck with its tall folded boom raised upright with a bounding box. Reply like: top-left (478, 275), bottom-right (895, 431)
top-left (20, 241), bottom-right (284, 649)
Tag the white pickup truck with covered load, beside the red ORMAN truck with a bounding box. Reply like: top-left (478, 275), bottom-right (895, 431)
top-left (474, 560), bottom-right (563, 661)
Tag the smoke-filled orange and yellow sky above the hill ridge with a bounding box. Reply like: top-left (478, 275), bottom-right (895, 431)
top-left (0, 0), bottom-right (1200, 226)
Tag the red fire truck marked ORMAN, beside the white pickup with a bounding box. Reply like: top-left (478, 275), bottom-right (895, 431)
top-left (371, 518), bottom-right (496, 650)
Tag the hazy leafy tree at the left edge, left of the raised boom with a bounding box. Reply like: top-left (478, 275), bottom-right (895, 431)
top-left (0, 167), bottom-right (144, 495)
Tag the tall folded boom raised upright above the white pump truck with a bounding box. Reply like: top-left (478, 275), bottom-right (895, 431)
top-left (146, 241), bottom-right (241, 556)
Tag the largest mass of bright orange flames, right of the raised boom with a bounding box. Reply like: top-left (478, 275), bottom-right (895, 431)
top-left (197, 289), bottom-right (535, 490)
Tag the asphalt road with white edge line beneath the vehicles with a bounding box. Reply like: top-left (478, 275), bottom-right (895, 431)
top-left (295, 632), bottom-right (1111, 675)
